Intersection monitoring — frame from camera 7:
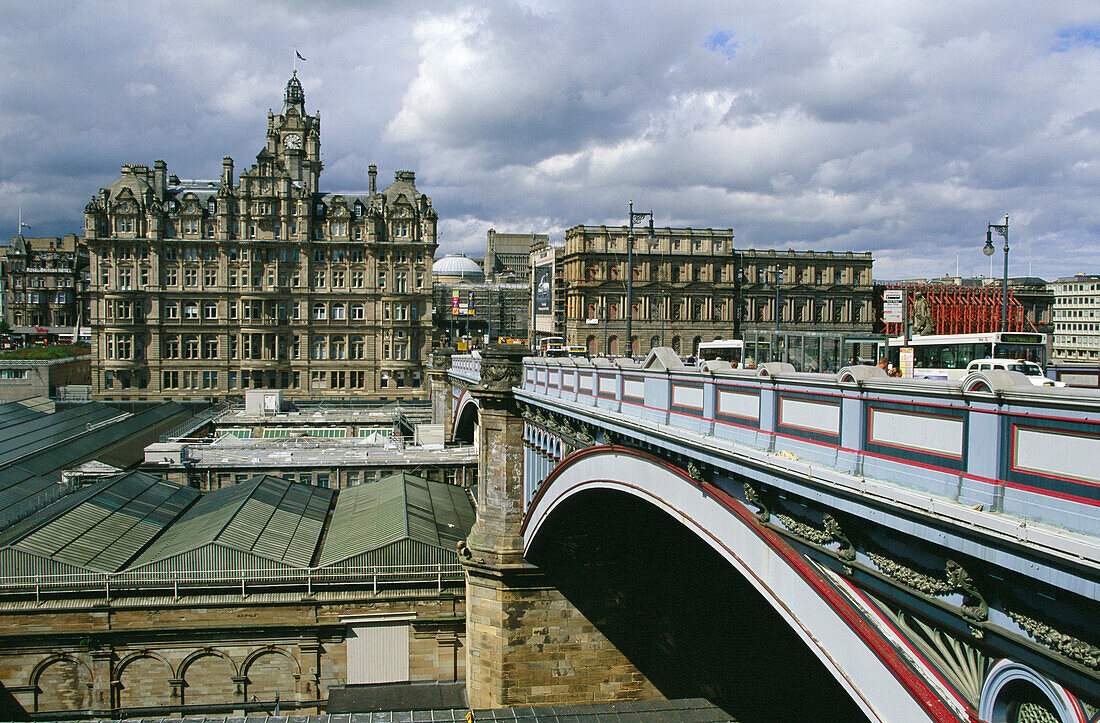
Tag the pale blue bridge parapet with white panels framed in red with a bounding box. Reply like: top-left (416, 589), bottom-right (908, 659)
top-left (519, 350), bottom-right (1100, 534)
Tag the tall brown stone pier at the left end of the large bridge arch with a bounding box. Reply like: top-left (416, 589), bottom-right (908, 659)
top-left (460, 344), bottom-right (660, 709)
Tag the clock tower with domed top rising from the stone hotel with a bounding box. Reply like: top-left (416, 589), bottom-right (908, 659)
top-left (267, 70), bottom-right (321, 194)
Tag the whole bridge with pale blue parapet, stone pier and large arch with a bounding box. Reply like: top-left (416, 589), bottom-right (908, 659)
top-left (432, 347), bottom-right (1100, 723)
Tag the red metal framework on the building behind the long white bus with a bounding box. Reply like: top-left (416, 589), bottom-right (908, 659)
top-left (875, 283), bottom-right (1038, 337)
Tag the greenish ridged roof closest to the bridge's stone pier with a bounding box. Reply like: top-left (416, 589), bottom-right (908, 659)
top-left (317, 472), bottom-right (474, 566)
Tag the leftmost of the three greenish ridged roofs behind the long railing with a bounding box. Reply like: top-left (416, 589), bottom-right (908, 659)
top-left (13, 472), bottom-right (199, 572)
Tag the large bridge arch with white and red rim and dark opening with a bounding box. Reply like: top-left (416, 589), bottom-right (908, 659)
top-left (524, 446), bottom-right (967, 721)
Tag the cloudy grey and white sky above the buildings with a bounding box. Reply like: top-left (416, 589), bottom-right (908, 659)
top-left (0, 0), bottom-right (1100, 278)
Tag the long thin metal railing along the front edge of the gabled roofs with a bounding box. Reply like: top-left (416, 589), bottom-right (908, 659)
top-left (0, 562), bottom-right (464, 601)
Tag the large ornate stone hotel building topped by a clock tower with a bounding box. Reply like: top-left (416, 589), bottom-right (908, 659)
top-left (85, 75), bottom-right (437, 401)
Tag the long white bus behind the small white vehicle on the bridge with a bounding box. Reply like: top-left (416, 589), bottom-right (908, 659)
top-left (887, 331), bottom-right (1046, 380)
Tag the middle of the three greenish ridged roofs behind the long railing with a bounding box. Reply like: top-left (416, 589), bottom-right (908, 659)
top-left (134, 474), bottom-right (333, 567)
